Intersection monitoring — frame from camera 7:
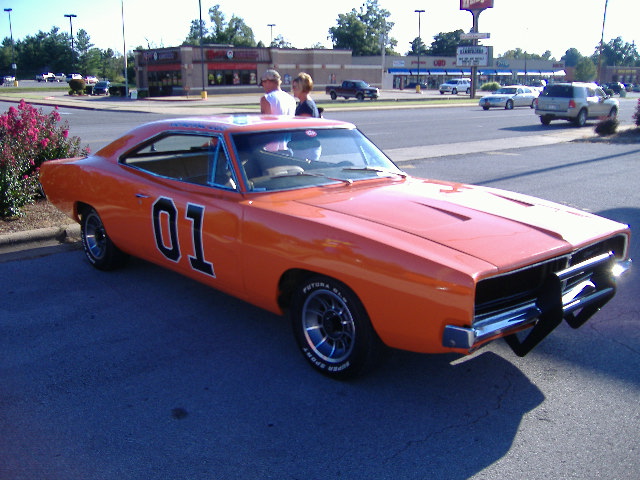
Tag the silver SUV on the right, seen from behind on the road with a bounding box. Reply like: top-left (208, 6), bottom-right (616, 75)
top-left (535, 82), bottom-right (619, 127)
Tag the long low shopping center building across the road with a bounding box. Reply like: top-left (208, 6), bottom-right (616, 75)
top-left (135, 45), bottom-right (640, 96)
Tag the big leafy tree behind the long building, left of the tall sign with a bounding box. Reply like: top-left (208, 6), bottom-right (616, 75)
top-left (329, 0), bottom-right (398, 56)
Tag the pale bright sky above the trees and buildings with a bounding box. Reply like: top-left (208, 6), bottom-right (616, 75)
top-left (0, 0), bottom-right (640, 60)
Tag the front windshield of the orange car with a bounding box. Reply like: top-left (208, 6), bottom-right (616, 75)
top-left (233, 128), bottom-right (405, 191)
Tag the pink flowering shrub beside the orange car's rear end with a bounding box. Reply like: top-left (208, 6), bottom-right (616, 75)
top-left (0, 100), bottom-right (89, 218)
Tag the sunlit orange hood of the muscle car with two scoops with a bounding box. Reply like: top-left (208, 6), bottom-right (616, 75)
top-left (299, 179), bottom-right (624, 268)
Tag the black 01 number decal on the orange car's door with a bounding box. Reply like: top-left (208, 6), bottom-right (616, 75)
top-left (153, 197), bottom-right (216, 277)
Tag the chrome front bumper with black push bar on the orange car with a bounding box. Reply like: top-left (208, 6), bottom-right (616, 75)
top-left (442, 252), bottom-right (631, 357)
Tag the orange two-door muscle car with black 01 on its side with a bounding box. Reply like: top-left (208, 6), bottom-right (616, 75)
top-left (41, 115), bottom-right (630, 378)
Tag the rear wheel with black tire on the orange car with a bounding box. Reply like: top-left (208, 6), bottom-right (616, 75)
top-left (81, 208), bottom-right (127, 270)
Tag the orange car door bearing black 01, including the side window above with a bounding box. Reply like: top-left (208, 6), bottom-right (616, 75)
top-left (114, 133), bottom-right (243, 294)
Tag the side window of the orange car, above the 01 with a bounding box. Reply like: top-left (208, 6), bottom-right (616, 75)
top-left (120, 134), bottom-right (237, 189)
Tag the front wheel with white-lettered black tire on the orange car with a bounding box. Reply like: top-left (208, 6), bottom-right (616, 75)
top-left (290, 276), bottom-right (384, 380)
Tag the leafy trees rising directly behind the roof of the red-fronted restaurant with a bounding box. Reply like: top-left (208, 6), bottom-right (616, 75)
top-left (183, 5), bottom-right (256, 47)
